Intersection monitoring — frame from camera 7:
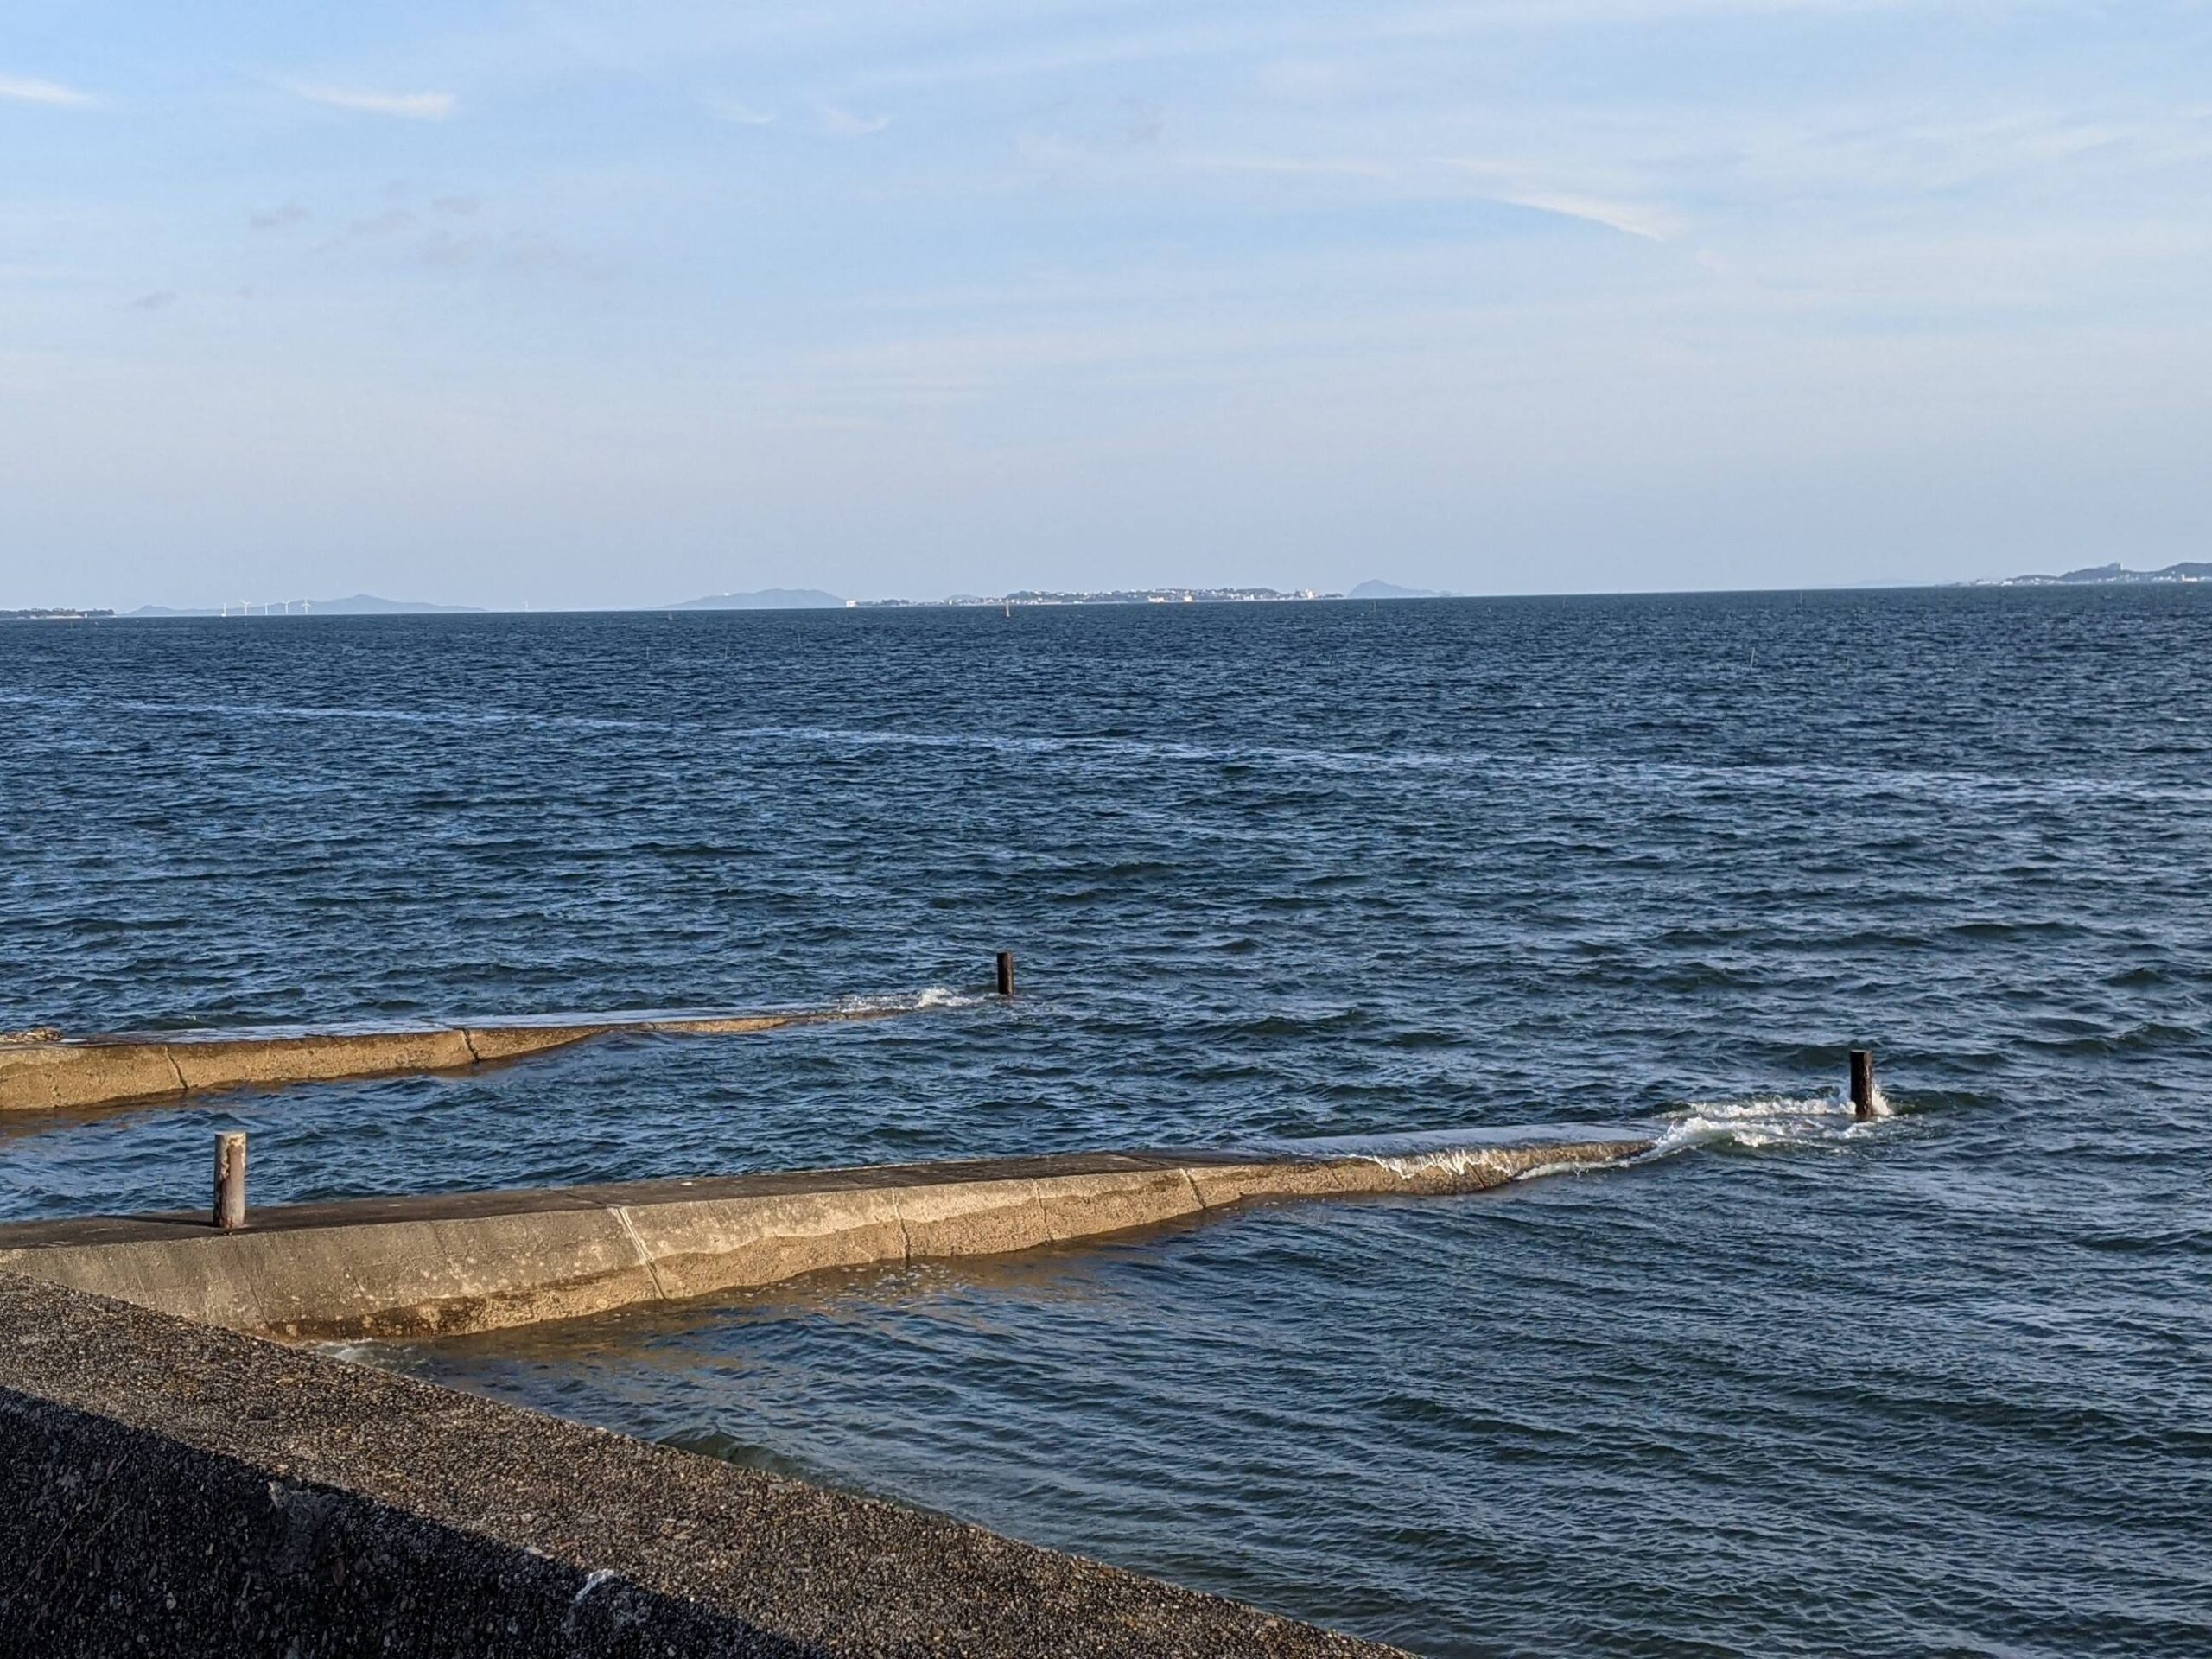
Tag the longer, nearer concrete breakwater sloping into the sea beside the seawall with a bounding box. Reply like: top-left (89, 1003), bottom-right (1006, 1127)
top-left (0, 1139), bottom-right (1650, 1338)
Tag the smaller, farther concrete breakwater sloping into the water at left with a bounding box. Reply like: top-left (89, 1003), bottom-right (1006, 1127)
top-left (0, 1004), bottom-right (913, 1113)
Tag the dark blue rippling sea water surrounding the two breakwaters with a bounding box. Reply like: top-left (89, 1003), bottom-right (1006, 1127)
top-left (0, 588), bottom-right (2212, 1655)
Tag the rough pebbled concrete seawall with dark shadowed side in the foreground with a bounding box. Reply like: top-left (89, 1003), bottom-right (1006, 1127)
top-left (0, 1274), bottom-right (1391, 1659)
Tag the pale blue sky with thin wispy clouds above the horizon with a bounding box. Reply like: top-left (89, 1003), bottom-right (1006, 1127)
top-left (0, 0), bottom-right (2212, 608)
